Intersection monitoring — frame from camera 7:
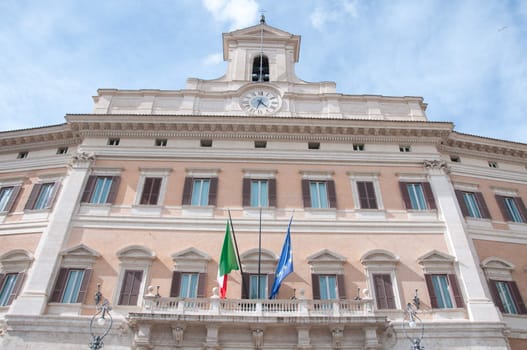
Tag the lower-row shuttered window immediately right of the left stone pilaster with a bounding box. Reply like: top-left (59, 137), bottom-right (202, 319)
top-left (49, 268), bottom-right (92, 304)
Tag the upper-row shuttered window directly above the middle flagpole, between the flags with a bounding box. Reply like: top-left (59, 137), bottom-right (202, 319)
top-left (243, 178), bottom-right (276, 208)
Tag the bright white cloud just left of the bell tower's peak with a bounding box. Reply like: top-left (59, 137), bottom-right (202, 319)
top-left (202, 0), bottom-right (258, 30)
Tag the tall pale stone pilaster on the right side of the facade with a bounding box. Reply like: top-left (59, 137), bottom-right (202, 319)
top-left (424, 160), bottom-right (500, 322)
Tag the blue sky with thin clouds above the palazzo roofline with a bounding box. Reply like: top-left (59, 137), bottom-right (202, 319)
top-left (0, 0), bottom-right (527, 143)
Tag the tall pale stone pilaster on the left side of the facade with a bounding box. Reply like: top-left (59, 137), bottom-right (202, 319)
top-left (9, 153), bottom-right (95, 315)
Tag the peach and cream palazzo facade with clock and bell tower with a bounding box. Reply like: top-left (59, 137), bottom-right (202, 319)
top-left (0, 20), bottom-right (527, 350)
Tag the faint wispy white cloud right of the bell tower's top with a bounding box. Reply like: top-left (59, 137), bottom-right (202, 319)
top-left (309, 0), bottom-right (358, 30)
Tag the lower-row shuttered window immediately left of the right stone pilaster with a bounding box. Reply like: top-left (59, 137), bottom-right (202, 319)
top-left (425, 274), bottom-right (464, 309)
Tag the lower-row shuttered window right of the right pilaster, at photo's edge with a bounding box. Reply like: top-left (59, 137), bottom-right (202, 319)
top-left (489, 280), bottom-right (527, 315)
